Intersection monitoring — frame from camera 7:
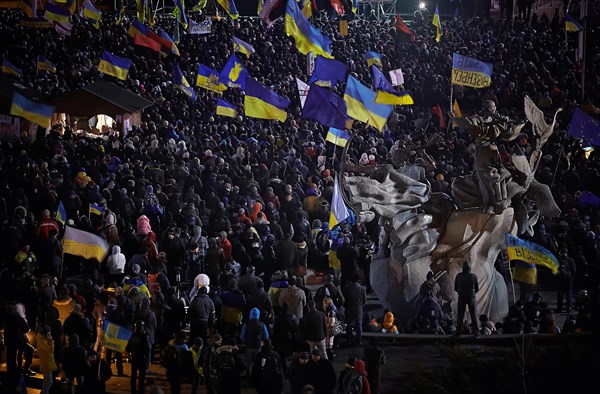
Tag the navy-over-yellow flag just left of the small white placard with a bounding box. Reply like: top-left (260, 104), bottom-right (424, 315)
top-left (244, 77), bottom-right (290, 122)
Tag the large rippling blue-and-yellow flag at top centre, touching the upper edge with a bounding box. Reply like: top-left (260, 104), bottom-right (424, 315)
top-left (285, 0), bottom-right (333, 59)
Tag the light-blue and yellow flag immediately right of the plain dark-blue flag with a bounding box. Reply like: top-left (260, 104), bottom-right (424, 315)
top-left (344, 76), bottom-right (394, 131)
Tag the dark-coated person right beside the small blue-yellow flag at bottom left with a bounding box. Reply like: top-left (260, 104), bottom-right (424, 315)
top-left (125, 320), bottom-right (150, 394)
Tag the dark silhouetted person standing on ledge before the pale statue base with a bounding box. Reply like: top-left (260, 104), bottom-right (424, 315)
top-left (454, 261), bottom-right (479, 337)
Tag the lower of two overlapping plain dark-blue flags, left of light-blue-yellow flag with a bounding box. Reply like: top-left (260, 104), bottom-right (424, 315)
top-left (301, 84), bottom-right (349, 129)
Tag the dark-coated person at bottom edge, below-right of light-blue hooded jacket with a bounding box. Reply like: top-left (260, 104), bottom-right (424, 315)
top-left (250, 339), bottom-right (283, 394)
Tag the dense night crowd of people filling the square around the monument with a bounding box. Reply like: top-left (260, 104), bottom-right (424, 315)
top-left (0, 0), bottom-right (600, 394)
